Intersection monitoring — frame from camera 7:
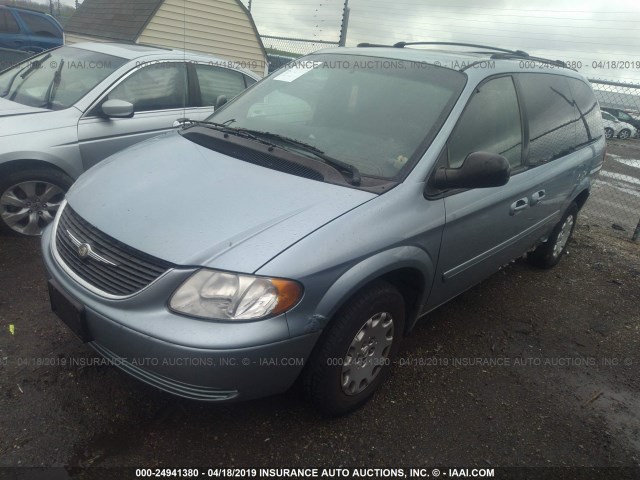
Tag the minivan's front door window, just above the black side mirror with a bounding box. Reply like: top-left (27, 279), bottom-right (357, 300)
top-left (448, 77), bottom-right (522, 168)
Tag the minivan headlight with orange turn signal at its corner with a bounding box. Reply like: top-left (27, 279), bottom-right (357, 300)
top-left (169, 269), bottom-right (302, 320)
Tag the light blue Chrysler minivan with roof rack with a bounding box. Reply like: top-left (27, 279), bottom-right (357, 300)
top-left (42, 43), bottom-right (605, 414)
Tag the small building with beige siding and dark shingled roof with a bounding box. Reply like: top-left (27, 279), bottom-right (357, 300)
top-left (65, 0), bottom-right (267, 76)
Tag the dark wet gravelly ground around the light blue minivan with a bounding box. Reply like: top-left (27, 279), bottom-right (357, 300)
top-left (0, 202), bottom-right (640, 478)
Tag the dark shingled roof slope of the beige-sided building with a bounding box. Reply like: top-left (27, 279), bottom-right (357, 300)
top-left (65, 0), bottom-right (164, 43)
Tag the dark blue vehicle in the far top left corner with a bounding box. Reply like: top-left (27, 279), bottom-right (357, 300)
top-left (0, 5), bottom-right (64, 53)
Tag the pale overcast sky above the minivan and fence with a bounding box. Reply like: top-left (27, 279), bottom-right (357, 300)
top-left (53, 0), bottom-right (640, 83)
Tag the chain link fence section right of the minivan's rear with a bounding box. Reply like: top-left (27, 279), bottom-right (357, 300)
top-left (583, 79), bottom-right (640, 241)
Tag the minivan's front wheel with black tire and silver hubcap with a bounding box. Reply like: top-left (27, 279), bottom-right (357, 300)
top-left (302, 281), bottom-right (405, 416)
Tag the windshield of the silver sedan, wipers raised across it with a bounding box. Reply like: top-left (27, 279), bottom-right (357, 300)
top-left (0, 47), bottom-right (127, 110)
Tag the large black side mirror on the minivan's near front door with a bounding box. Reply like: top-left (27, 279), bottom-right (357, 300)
top-left (433, 152), bottom-right (511, 190)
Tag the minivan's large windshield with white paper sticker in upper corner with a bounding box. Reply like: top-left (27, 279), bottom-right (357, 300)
top-left (207, 53), bottom-right (466, 180)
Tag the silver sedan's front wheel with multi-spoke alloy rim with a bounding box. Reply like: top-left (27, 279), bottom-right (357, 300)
top-left (0, 167), bottom-right (73, 236)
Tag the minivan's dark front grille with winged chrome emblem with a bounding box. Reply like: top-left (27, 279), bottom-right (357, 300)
top-left (55, 205), bottom-right (173, 297)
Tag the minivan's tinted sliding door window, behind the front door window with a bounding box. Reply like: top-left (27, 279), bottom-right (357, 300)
top-left (518, 73), bottom-right (576, 166)
